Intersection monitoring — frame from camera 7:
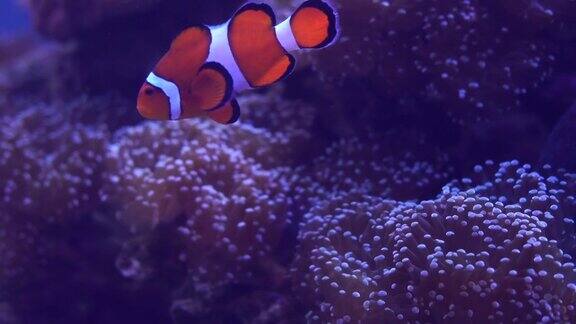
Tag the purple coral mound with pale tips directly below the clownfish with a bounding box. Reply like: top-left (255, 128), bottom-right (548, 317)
top-left (103, 119), bottom-right (306, 294)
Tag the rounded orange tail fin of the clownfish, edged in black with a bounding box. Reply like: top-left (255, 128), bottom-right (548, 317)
top-left (290, 0), bottom-right (340, 48)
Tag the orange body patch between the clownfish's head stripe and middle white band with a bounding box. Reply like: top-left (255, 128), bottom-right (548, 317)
top-left (155, 25), bottom-right (212, 81)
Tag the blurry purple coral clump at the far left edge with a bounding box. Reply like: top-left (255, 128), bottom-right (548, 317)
top-left (0, 101), bottom-right (108, 308)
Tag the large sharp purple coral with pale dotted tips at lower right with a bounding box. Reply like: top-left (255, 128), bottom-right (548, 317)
top-left (293, 162), bottom-right (576, 323)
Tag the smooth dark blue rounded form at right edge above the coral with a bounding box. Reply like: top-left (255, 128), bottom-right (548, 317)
top-left (540, 104), bottom-right (576, 172)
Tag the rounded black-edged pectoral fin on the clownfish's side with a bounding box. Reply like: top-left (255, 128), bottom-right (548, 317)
top-left (190, 62), bottom-right (234, 110)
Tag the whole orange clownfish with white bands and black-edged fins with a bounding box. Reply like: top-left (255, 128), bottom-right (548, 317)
top-left (137, 0), bottom-right (338, 124)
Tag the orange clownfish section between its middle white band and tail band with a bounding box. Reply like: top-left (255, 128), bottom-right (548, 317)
top-left (228, 3), bottom-right (296, 88)
